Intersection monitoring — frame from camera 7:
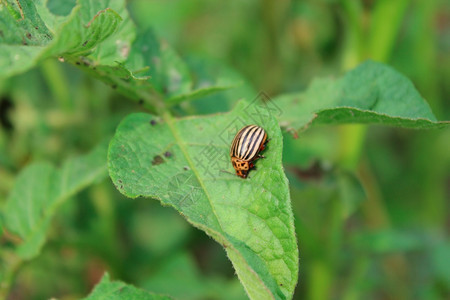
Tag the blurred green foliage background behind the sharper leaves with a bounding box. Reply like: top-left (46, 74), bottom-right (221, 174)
top-left (0, 0), bottom-right (450, 299)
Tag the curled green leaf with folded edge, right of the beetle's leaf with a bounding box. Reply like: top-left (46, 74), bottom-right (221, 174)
top-left (276, 61), bottom-right (450, 129)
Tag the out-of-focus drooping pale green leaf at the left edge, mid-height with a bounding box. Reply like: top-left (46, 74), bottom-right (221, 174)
top-left (4, 143), bottom-right (106, 259)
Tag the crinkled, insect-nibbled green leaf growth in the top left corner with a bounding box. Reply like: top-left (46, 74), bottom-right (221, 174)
top-left (0, 0), bottom-right (236, 111)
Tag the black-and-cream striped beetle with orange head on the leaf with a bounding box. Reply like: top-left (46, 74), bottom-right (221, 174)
top-left (230, 125), bottom-right (268, 178)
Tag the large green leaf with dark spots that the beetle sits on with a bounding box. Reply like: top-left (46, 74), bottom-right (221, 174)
top-left (108, 101), bottom-right (298, 299)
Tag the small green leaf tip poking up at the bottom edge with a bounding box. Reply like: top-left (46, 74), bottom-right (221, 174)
top-left (83, 273), bottom-right (172, 300)
